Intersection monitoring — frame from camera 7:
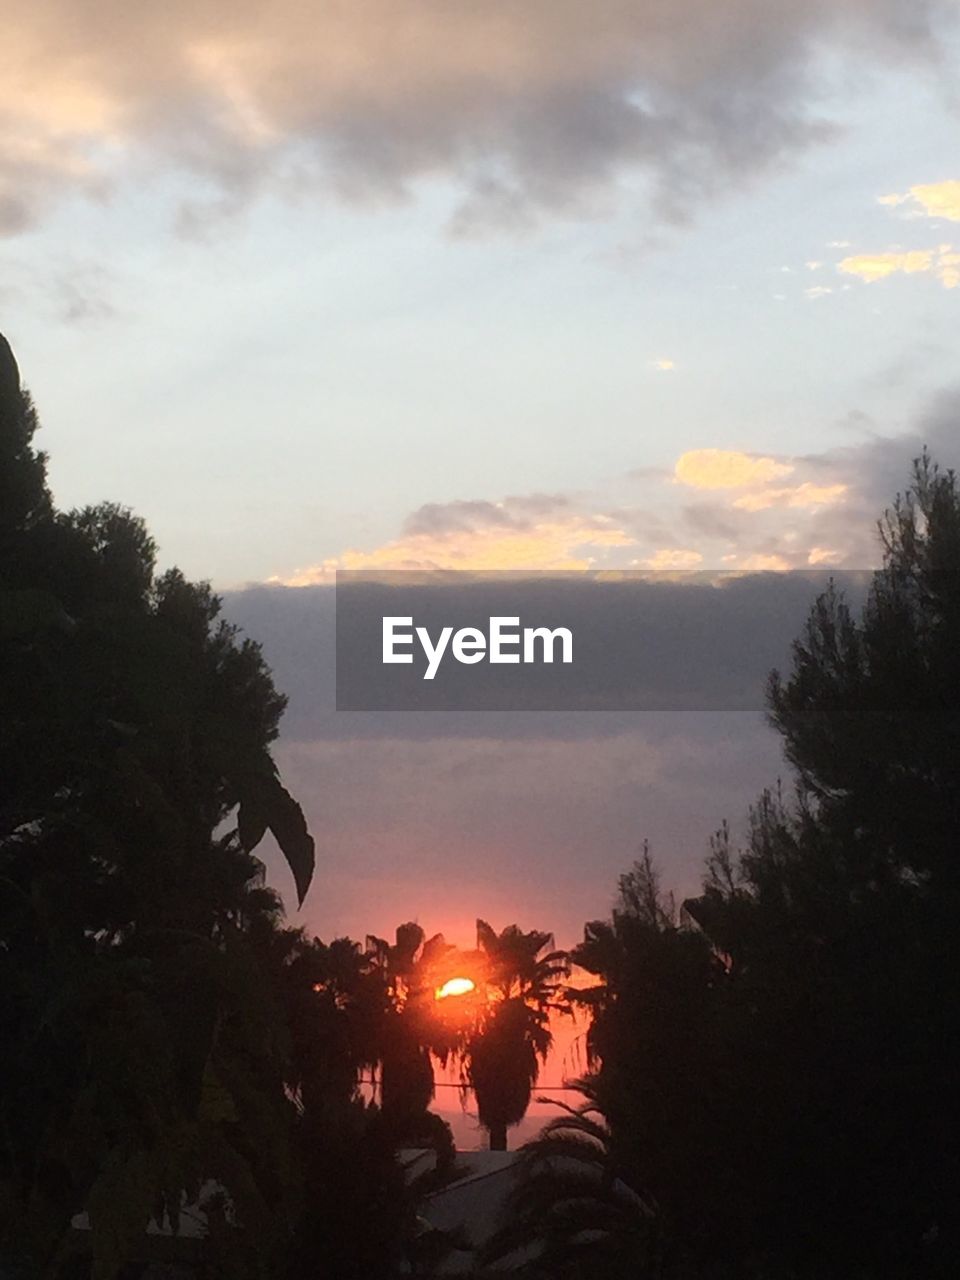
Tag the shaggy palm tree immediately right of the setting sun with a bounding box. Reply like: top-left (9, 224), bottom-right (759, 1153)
top-left (462, 920), bottom-right (570, 1151)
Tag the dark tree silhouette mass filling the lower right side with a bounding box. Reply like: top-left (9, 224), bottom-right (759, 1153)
top-left (555, 457), bottom-right (960, 1280)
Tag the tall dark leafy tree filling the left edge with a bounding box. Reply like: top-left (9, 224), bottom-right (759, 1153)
top-left (0, 340), bottom-right (314, 1280)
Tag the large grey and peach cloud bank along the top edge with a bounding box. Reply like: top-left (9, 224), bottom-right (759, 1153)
top-left (0, 0), bottom-right (946, 233)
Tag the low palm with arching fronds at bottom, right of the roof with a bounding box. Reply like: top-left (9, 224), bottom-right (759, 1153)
top-left (484, 1079), bottom-right (657, 1280)
